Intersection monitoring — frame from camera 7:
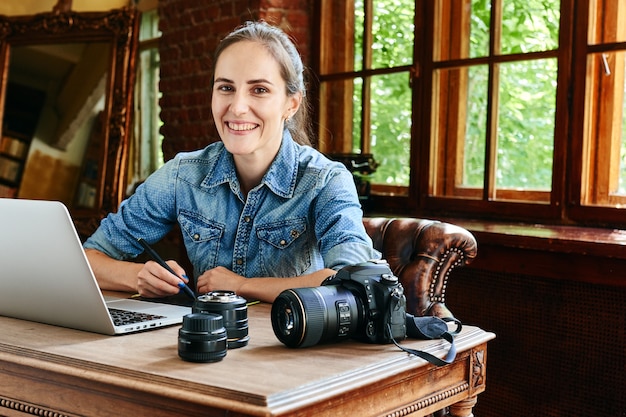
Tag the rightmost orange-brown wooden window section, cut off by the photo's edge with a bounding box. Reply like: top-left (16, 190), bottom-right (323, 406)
top-left (577, 0), bottom-right (626, 214)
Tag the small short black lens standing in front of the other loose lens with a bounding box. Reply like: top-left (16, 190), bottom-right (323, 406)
top-left (178, 313), bottom-right (227, 362)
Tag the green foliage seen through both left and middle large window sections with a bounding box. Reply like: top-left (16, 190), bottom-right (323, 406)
top-left (353, 0), bottom-right (560, 190)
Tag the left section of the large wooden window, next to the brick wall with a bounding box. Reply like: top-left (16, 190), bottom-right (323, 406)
top-left (320, 0), bottom-right (415, 194)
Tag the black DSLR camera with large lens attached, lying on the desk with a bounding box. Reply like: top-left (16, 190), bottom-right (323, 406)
top-left (271, 260), bottom-right (406, 348)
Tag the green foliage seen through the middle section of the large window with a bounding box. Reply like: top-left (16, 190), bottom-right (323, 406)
top-left (464, 0), bottom-right (560, 191)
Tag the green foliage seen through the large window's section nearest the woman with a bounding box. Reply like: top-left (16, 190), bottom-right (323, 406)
top-left (353, 0), bottom-right (415, 186)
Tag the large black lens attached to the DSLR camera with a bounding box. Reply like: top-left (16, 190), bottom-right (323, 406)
top-left (271, 285), bottom-right (363, 347)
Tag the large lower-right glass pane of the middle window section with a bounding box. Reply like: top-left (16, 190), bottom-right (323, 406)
top-left (496, 59), bottom-right (557, 191)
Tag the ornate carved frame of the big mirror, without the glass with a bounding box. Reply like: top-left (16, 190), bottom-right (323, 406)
top-left (0, 8), bottom-right (139, 238)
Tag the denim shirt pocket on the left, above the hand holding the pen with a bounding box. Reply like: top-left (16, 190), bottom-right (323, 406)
top-left (178, 210), bottom-right (225, 276)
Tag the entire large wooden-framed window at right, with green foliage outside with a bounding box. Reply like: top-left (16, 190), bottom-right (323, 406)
top-left (317, 0), bottom-right (626, 228)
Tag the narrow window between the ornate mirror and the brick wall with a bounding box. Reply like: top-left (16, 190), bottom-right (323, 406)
top-left (127, 8), bottom-right (164, 194)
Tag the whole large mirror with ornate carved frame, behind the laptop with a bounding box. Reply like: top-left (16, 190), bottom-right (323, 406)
top-left (0, 8), bottom-right (139, 238)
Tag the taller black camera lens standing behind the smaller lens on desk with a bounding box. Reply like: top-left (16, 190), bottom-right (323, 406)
top-left (191, 291), bottom-right (250, 349)
